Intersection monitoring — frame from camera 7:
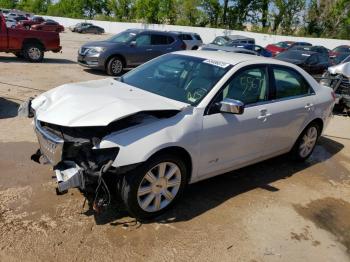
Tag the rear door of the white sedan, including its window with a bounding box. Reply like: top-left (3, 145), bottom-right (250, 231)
top-left (265, 65), bottom-right (315, 154)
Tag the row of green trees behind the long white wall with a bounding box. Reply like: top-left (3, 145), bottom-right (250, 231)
top-left (0, 0), bottom-right (350, 39)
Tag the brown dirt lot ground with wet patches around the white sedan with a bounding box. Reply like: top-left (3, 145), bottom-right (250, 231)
top-left (0, 33), bottom-right (350, 262)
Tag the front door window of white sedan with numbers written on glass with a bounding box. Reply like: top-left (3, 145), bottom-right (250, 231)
top-left (222, 66), bottom-right (269, 105)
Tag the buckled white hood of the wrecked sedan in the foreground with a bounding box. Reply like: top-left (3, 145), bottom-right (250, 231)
top-left (32, 78), bottom-right (189, 127)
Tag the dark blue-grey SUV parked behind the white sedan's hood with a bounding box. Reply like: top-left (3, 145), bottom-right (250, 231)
top-left (78, 29), bottom-right (186, 75)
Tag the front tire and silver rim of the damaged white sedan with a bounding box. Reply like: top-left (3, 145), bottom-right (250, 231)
top-left (120, 154), bottom-right (188, 220)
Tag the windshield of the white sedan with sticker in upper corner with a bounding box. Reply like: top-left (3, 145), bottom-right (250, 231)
top-left (121, 54), bottom-right (232, 106)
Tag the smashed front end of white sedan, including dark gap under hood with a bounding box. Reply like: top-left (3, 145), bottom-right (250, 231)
top-left (28, 110), bottom-right (178, 209)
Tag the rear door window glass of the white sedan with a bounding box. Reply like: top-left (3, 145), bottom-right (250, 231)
top-left (273, 68), bottom-right (313, 99)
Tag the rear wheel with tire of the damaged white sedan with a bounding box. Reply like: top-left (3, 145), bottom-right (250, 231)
top-left (291, 123), bottom-right (321, 161)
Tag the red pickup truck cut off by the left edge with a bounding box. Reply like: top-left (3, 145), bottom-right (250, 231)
top-left (0, 14), bottom-right (62, 62)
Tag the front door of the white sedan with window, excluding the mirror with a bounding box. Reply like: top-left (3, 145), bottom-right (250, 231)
top-left (198, 65), bottom-right (270, 178)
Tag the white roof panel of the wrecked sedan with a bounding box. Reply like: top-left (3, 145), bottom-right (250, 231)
top-left (173, 50), bottom-right (290, 66)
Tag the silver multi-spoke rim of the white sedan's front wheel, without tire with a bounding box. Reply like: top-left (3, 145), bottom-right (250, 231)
top-left (137, 162), bottom-right (181, 212)
